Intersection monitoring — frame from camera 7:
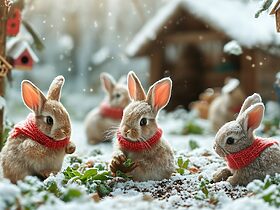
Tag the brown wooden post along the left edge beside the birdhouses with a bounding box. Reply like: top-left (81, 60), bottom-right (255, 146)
top-left (0, 0), bottom-right (8, 149)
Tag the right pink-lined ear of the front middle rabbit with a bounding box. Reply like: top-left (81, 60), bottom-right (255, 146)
top-left (147, 78), bottom-right (172, 112)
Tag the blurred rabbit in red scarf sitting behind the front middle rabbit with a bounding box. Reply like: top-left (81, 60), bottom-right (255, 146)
top-left (85, 73), bottom-right (130, 144)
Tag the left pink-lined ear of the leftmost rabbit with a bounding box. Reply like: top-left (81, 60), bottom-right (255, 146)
top-left (21, 80), bottom-right (47, 114)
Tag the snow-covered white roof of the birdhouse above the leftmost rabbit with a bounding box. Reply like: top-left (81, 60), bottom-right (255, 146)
top-left (7, 37), bottom-right (39, 63)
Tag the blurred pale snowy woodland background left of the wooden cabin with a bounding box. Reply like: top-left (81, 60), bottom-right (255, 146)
top-left (6, 0), bottom-right (166, 119)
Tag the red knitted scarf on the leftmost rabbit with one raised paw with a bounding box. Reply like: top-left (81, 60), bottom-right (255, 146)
top-left (10, 113), bottom-right (70, 149)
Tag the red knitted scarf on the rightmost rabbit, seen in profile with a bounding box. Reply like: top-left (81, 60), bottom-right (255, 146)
top-left (226, 138), bottom-right (278, 170)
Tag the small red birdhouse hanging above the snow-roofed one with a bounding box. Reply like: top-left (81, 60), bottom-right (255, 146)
top-left (7, 8), bottom-right (21, 36)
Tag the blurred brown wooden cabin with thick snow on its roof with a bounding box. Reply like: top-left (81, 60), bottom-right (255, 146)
top-left (126, 0), bottom-right (280, 108)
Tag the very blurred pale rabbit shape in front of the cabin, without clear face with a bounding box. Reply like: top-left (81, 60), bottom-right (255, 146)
top-left (208, 79), bottom-right (246, 131)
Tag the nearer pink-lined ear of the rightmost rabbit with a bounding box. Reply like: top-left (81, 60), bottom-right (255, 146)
top-left (237, 103), bottom-right (264, 132)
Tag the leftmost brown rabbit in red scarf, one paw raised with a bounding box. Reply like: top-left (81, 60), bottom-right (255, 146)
top-left (1, 76), bottom-right (76, 183)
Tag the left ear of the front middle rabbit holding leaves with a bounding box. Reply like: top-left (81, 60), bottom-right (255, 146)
top-left (127, 71), bottom-right (146, 101)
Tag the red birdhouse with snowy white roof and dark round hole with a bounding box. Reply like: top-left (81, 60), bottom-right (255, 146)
top-left (7, 38), bottom-right (39, 70)
